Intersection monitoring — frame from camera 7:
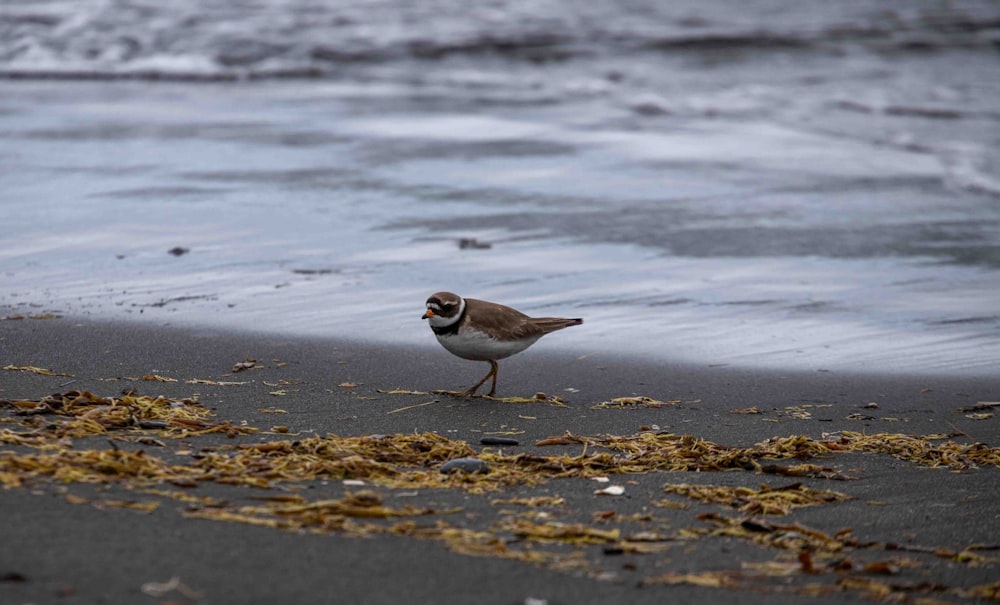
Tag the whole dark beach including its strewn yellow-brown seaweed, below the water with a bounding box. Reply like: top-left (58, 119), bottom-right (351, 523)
top-left (0, 318), bottom-right (1000, 604)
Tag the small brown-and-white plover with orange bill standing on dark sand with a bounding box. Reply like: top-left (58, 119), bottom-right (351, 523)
top-left (421, 292), bottom-right (583, 397)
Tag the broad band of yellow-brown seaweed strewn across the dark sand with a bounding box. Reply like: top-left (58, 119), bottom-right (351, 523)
top-left (0, 384), bottom-right (1000, 601)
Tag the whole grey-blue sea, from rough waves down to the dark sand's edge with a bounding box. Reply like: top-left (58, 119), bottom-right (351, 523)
top-left (0, 0), bottom-right (1000, 376)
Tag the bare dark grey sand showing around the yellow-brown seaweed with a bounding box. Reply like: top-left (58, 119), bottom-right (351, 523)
top-left (0, 318), bottom-right (1000, 605)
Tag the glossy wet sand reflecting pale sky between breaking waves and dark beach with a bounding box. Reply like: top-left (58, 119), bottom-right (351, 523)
top-left (0, 77), bottom-right (1000, 376)
